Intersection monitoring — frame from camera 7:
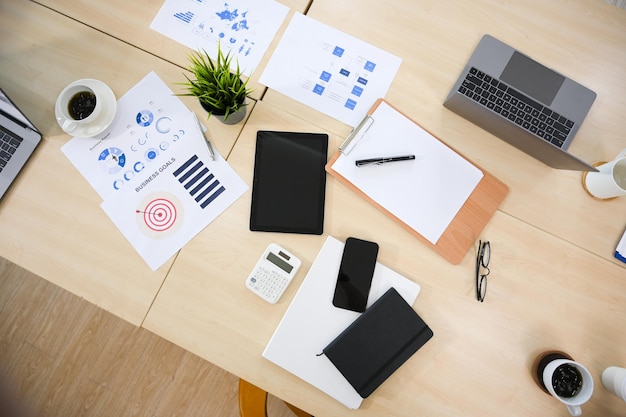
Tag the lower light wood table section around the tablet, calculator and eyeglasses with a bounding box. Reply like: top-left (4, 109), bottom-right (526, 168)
top-left (144, 101), bottom-right (626, 416)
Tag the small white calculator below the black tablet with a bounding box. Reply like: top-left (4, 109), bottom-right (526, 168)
top-left (246, 243), bottom-right (301, 304)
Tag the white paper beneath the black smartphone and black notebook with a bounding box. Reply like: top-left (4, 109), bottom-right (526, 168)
top-left (263, 236), bottom-right (420, 409)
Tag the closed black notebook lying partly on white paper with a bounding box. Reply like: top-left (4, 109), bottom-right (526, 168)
top-left (324, 288), bottom-right (433, 398)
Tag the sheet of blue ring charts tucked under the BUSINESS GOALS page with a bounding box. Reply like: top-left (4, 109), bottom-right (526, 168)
top-left (61, 72), bottom-right (200, 199)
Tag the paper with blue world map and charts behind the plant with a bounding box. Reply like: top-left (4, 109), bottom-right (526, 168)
top-left (150, 0), bottom-right (289, 76)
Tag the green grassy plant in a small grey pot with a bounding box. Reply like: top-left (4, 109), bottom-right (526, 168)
top-left (179, 44), bottom-right (252, 124)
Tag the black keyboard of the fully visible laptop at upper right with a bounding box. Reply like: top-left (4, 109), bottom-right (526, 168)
top-left (458, 67), bottom-right (574, 148)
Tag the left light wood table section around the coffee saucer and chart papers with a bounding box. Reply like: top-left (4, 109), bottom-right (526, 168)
top-left (0, 0), bottom-right (255, 325)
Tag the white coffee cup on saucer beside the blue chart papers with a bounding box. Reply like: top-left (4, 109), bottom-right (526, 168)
top-left (55, 79), bottom-right (103, 133)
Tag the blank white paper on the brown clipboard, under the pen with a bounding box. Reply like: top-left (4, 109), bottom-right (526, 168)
top-left (333, 102), bottom-right (483, 244)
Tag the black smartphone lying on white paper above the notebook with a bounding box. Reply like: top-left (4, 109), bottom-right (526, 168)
top-left (333, 237), bottom-right (378, 313)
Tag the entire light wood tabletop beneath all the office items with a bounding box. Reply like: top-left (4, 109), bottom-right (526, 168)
top-left (0, 0), bottom-right (626, 416)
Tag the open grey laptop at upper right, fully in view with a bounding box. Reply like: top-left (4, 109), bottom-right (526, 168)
top-left (444, 35), bottom-right (597, 171)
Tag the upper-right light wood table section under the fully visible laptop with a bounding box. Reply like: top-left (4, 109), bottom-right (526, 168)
top-left (263, 0), bottom-right (626, 263)
